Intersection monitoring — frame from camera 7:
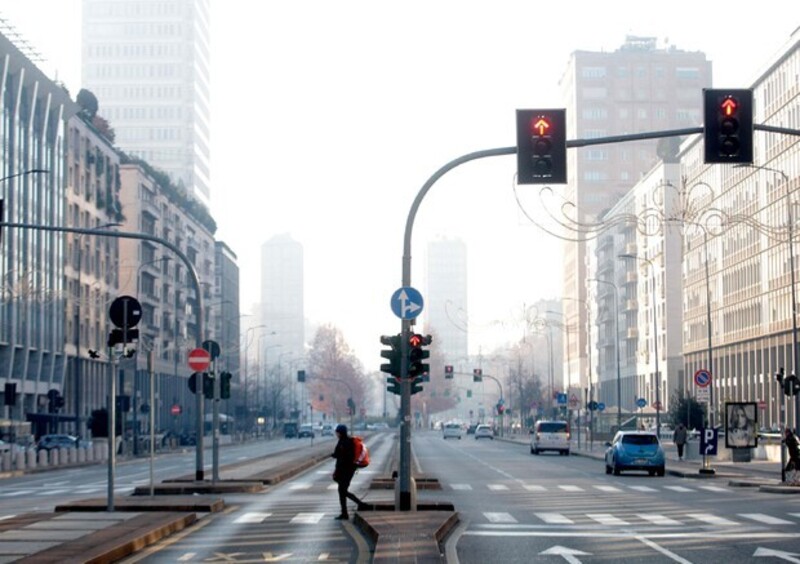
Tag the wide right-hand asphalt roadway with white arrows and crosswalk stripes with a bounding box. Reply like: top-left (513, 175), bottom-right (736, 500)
top-left (414, 432), bottom-right (800, 564)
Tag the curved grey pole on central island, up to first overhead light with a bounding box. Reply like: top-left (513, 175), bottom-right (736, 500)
top-left (397, 146), bottom-right (517, 511)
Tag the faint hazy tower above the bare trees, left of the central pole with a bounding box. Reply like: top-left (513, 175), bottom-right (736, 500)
top-left (261, 234), bottom-right (305, 364)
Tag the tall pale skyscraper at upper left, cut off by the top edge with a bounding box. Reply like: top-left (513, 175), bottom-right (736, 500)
top-left (82, 0), bottom-right (211, 206)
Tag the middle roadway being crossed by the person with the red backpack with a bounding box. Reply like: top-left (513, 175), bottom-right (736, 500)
top-left (124, 433), bottom-right (396, 563)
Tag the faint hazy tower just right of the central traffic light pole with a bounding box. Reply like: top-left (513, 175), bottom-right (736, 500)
top-left (424, 239), bottom-right (469, 364)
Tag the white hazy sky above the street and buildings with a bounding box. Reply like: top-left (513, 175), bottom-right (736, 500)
top-left (0, 0), bottom-right (800, 370)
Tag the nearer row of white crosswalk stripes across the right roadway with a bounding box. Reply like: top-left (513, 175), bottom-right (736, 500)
top-left (484, 511), bottom-right (800, 527)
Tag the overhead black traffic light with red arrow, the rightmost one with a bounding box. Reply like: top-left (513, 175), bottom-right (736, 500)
top-left (703, 88), bottom-right (753, 164)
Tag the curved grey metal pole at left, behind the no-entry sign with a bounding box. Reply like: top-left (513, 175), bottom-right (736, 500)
top-left (0, 222), bottom-right (204, 481)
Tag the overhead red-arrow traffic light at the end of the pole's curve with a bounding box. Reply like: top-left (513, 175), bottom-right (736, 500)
top-left (517, 109), bottom-right (567, 184)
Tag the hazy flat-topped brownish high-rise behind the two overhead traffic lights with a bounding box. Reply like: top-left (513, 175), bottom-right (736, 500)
top-left (561, 37), bottom-right (711, 387)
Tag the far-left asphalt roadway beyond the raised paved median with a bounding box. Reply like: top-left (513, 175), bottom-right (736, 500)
top-left (0, 437), bottom-right (334, 519)
